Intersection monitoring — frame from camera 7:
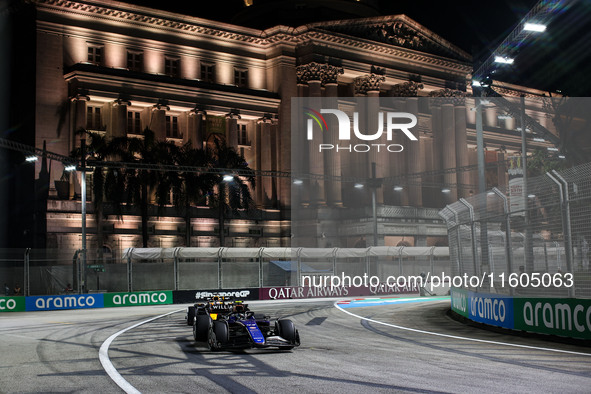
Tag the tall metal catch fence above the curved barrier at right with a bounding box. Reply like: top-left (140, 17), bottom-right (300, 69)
top-left (439, 163), bottom-right (591, 298)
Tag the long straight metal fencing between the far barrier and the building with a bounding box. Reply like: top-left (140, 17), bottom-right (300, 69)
top-left (0, 246), bottom-right (451, 295)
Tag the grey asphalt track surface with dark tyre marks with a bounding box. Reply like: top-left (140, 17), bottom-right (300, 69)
top-left (0, 300), bottom-right (591, 393)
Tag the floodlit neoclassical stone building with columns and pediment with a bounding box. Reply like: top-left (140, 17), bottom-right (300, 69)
top-left (2, 0), bottom-right (551, 250)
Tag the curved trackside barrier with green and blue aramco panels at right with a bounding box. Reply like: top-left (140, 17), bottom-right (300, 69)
top-left (451, 288), bottom-right (591, 339)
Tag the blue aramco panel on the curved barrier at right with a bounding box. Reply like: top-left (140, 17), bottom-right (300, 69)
top-left (468, 291), bottom-right (514, 328)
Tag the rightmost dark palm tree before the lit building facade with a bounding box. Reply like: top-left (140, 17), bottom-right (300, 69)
top-left (213, 139), bottom-right (255, 246)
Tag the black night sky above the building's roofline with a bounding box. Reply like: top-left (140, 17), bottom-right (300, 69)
top-left (112, 0), bottom-right (591, 96)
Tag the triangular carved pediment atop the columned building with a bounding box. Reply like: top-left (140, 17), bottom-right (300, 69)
top-left (308, 15), bottom-right (471, 62)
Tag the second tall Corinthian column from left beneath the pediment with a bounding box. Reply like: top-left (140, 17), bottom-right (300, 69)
top-left (323, 65), bottom-right (343, 206)
